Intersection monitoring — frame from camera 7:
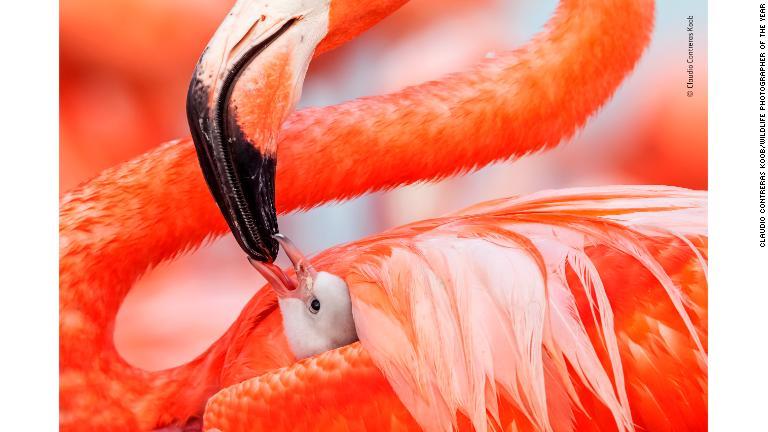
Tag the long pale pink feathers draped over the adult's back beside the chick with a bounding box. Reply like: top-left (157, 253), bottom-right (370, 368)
top-left (348, 186), bottom-right (706, 431)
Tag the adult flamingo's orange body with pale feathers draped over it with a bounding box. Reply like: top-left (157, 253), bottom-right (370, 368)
top-left (205, 187), bottom-right (707, 431)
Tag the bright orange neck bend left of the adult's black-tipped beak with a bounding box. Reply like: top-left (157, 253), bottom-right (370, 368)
top-left (59, 153), bottom-right (290, 430)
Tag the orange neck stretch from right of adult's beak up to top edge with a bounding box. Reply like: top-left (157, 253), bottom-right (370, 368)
top-left (276, 0), bottom-right (654, 212)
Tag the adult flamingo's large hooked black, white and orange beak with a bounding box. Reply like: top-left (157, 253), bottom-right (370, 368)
top-left (187, 0), bottom-right (329, 263)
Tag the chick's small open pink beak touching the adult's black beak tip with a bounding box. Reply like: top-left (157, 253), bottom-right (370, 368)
top-left (248, 234), bottom-right (317, 298)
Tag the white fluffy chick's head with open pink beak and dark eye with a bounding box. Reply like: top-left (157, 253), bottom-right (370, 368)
top-left (249, 234), bottom-right (357, 359)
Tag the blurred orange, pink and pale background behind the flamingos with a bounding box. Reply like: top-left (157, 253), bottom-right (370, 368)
top-left (60, 0), bottom-right (707, 369)
